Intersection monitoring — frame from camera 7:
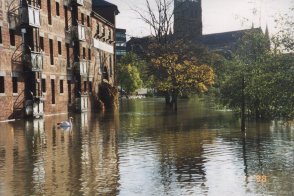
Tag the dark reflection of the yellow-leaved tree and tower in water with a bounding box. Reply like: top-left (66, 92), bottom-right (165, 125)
top-left (160, 130), bottom-right (214, 193)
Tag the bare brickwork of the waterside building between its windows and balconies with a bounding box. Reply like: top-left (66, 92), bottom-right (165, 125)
top-left (0, 0), bottom-right (114, 120)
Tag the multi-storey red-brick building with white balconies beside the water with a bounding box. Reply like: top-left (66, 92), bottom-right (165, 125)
top-left (0, 0), bottom-right (118, 120)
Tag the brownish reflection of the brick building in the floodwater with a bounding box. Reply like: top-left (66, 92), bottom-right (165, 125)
top-left (0, 112), bottom-right (119, 195)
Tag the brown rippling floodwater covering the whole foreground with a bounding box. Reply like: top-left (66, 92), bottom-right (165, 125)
top-left (0, 99), bottom-right (294, 196)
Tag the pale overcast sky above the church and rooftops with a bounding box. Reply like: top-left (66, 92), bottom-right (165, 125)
top-left (107, 0), bottom-right (294, 37)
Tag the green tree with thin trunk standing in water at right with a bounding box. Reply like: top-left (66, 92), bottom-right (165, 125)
top-left (221, 29), bottom-right (270, 130)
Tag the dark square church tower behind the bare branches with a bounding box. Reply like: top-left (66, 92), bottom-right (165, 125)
top-left (174, 0), bottom-right (202, 39)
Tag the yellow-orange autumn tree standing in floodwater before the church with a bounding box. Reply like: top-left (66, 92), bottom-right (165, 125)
top-left (151, 45), bottom-right (214, 111)
